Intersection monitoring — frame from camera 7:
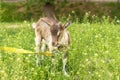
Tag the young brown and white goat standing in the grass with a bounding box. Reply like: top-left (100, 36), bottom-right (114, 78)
top-left (32, 17), bottom-right (70, 75)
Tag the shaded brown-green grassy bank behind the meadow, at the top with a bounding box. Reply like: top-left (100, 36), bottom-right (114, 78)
top-left (0, 0), bottom-right (120, 22)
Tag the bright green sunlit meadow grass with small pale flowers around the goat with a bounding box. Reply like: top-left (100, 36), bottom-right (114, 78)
top-left (0, 22), bottom-right (120, 80)
